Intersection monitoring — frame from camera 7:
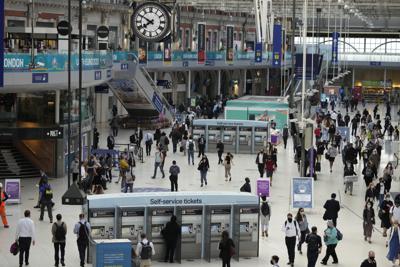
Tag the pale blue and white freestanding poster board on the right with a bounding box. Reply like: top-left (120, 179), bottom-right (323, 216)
top-left (291, 177), bottom-right (314, 209)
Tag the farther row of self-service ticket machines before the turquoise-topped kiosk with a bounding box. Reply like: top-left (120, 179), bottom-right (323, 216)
top-left (192, 120), bottom-right (269, 153)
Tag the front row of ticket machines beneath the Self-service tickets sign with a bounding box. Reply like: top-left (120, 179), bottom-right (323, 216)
top-left (88, 193), bottom-right (259, 262)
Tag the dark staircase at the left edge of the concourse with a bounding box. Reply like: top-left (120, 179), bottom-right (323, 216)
top-left (0, 140), bottom-right (40, 179)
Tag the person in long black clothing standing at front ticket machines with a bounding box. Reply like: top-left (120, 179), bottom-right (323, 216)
top-left (161, 215), bottom-right (181, 263)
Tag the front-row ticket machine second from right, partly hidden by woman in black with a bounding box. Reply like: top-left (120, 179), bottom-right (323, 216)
top-left (208, 206), bottom-right (231, 258)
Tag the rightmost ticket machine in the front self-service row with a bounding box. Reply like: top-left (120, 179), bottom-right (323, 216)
top-left (239, 205), bottom-right (260, 257)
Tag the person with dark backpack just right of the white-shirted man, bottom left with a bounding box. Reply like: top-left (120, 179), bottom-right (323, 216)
top-left (51, 214), bottom-right (67, 267)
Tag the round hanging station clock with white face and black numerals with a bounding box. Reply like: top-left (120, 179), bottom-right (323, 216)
top-left (132, 2), bottom-right (171, 42)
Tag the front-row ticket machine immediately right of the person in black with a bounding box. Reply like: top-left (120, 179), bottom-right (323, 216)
top-left (181, 206), bottom-right (203, 259)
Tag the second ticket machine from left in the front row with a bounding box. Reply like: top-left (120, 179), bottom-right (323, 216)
top-left (117, 207), bottom-right (146, 245)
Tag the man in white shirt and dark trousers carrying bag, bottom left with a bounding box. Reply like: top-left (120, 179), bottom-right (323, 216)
top-left (15, 210), bottom-right (35, 267)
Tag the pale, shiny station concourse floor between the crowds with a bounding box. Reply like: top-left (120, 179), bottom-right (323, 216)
top-left (0, 107), bottom-right (400, 267)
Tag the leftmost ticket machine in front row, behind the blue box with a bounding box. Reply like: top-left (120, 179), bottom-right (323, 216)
top-left (87, 208), bottom-right (116, 263)
